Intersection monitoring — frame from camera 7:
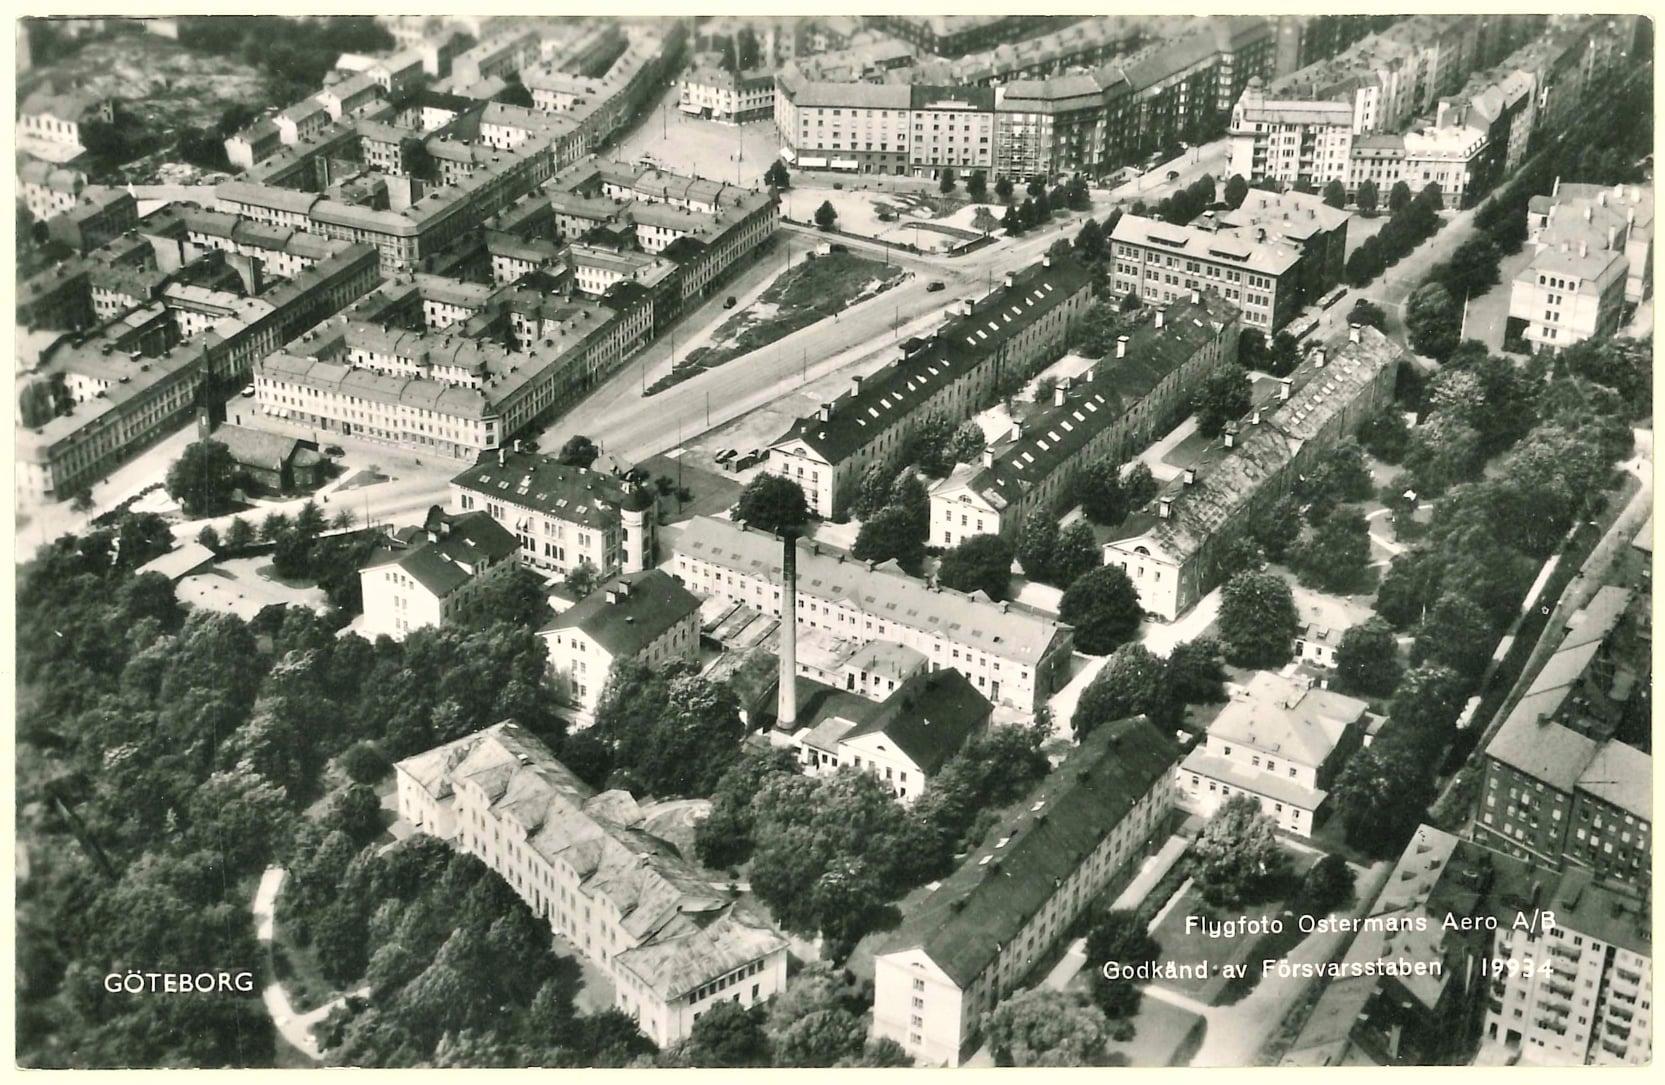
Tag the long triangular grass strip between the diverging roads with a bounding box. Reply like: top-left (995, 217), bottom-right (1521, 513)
top-left (662, 253), bottom-right (904, 377)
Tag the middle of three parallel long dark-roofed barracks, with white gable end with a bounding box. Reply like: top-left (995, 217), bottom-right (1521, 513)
top-left (931, 293), bottom-right (1242, 547)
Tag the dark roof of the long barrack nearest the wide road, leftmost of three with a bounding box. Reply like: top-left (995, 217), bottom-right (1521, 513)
top-left (774, 260), bottom-right (1089, 463)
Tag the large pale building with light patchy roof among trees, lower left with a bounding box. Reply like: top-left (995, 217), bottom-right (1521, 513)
top-left (395, 721), bottom-right (788, 1047)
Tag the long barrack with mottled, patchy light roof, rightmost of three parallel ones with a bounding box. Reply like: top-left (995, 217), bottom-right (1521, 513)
top-left (1104, 326), bottom-right (1400, 621)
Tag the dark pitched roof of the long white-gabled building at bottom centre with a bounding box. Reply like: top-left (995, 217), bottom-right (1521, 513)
top-left (881, 716), bottom-right (1179, 988)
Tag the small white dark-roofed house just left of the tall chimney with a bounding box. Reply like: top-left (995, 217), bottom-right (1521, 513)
top-left (538, 569), bottom-right (699, 727)
